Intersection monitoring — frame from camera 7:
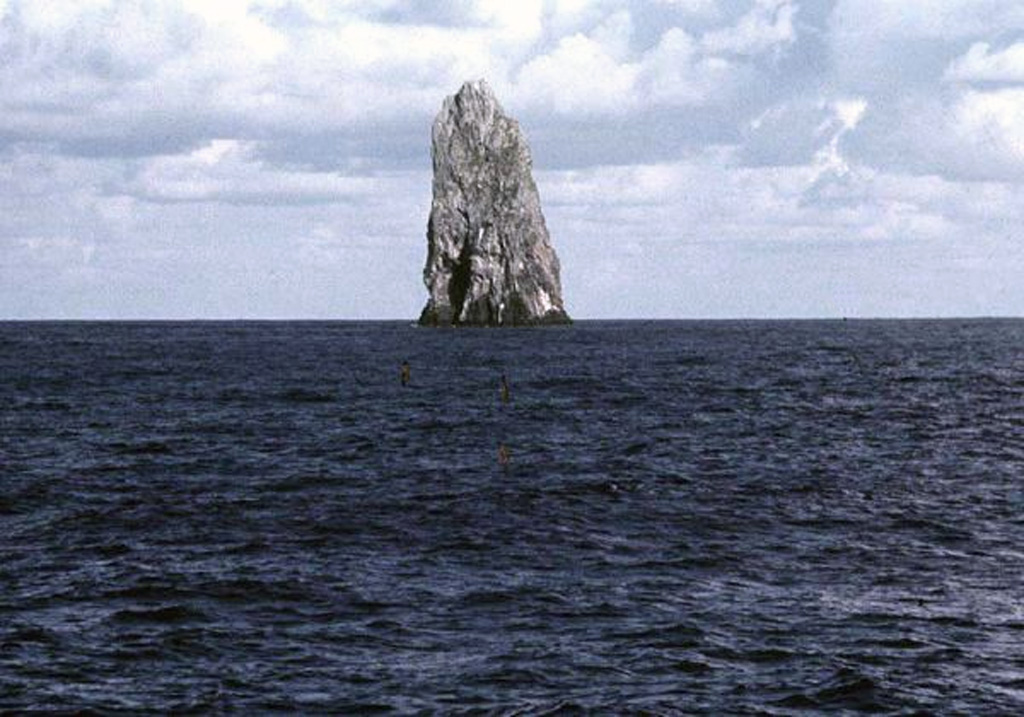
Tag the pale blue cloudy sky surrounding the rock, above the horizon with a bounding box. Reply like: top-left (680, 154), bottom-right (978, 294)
top-left (0, 0), bottom-right (1024, 320)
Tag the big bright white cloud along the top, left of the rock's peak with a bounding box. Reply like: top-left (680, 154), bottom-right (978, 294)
top-left (0, 0), bottom-right (505, 154)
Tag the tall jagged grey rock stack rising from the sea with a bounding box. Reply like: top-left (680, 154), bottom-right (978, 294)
top-left (420, 80), bottom-right (569, 326)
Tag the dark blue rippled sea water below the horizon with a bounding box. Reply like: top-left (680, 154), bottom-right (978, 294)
top-left (0, 321), bottom-right (1024, 714)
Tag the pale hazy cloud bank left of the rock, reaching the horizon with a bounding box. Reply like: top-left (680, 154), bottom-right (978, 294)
top-left (0, 136), bottom-right (430, 319)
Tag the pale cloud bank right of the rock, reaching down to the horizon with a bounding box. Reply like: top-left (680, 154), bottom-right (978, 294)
top-left (539, 141), bottom-right (1024, 317)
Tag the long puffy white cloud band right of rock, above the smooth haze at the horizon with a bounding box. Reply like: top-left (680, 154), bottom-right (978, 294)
top-left (541, 141), bottom-right (991, 252)
